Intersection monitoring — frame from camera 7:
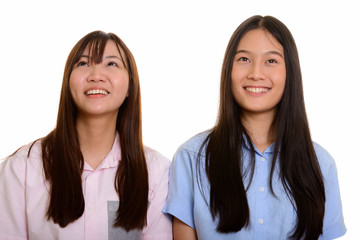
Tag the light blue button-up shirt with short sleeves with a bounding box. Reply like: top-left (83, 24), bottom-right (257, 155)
top-left (163, 131), bottom-right (346, 240)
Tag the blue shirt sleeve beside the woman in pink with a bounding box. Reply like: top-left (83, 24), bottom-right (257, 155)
top-left (163, 147), bottom-right (196, 229)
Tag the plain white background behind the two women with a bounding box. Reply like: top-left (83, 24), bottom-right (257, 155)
top-left (0, 0), bottom-right (360, 239)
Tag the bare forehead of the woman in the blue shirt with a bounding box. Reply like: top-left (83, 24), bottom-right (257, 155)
top-left (237, 29), bottom-right (284, 53)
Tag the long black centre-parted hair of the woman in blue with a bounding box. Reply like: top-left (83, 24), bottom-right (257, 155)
top-left (197, 16), bottom-right (325, 239)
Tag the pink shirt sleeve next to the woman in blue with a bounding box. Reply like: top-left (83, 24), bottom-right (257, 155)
top-left (142, 154), bottom-right (172, 240)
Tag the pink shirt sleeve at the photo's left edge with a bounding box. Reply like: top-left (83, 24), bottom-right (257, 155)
top-left (0, 149), bottom-right (27, 240)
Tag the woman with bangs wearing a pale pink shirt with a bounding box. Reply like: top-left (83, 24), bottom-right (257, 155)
top-left (0, 31), bottom-right (172, 240)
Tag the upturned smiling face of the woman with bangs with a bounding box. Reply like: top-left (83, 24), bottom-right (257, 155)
top-left (69, 40), bottom-right (129, 117)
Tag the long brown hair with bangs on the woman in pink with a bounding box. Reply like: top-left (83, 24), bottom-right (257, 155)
top-left (38, 31), bottom-right (149, 231)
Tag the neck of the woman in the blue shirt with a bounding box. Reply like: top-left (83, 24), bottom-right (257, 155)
top-left (241, 111), bottom-right (275, 152)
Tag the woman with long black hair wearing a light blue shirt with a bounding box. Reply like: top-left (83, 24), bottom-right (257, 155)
top-left (164, 16), bottom-right (346, 240)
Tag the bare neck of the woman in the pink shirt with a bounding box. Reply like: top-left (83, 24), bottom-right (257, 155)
top-left (76, 113), bottom-right (116, 169)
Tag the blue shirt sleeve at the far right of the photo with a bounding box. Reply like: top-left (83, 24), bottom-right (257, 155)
top-left (318, 147), bottom-right (346, 240)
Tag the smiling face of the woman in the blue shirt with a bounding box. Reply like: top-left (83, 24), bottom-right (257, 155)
top-left (231, 29), bottom-right (286, 117)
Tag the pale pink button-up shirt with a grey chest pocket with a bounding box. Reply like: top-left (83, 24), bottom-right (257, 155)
top-left (0, 136), bottom-right (172, 240)
